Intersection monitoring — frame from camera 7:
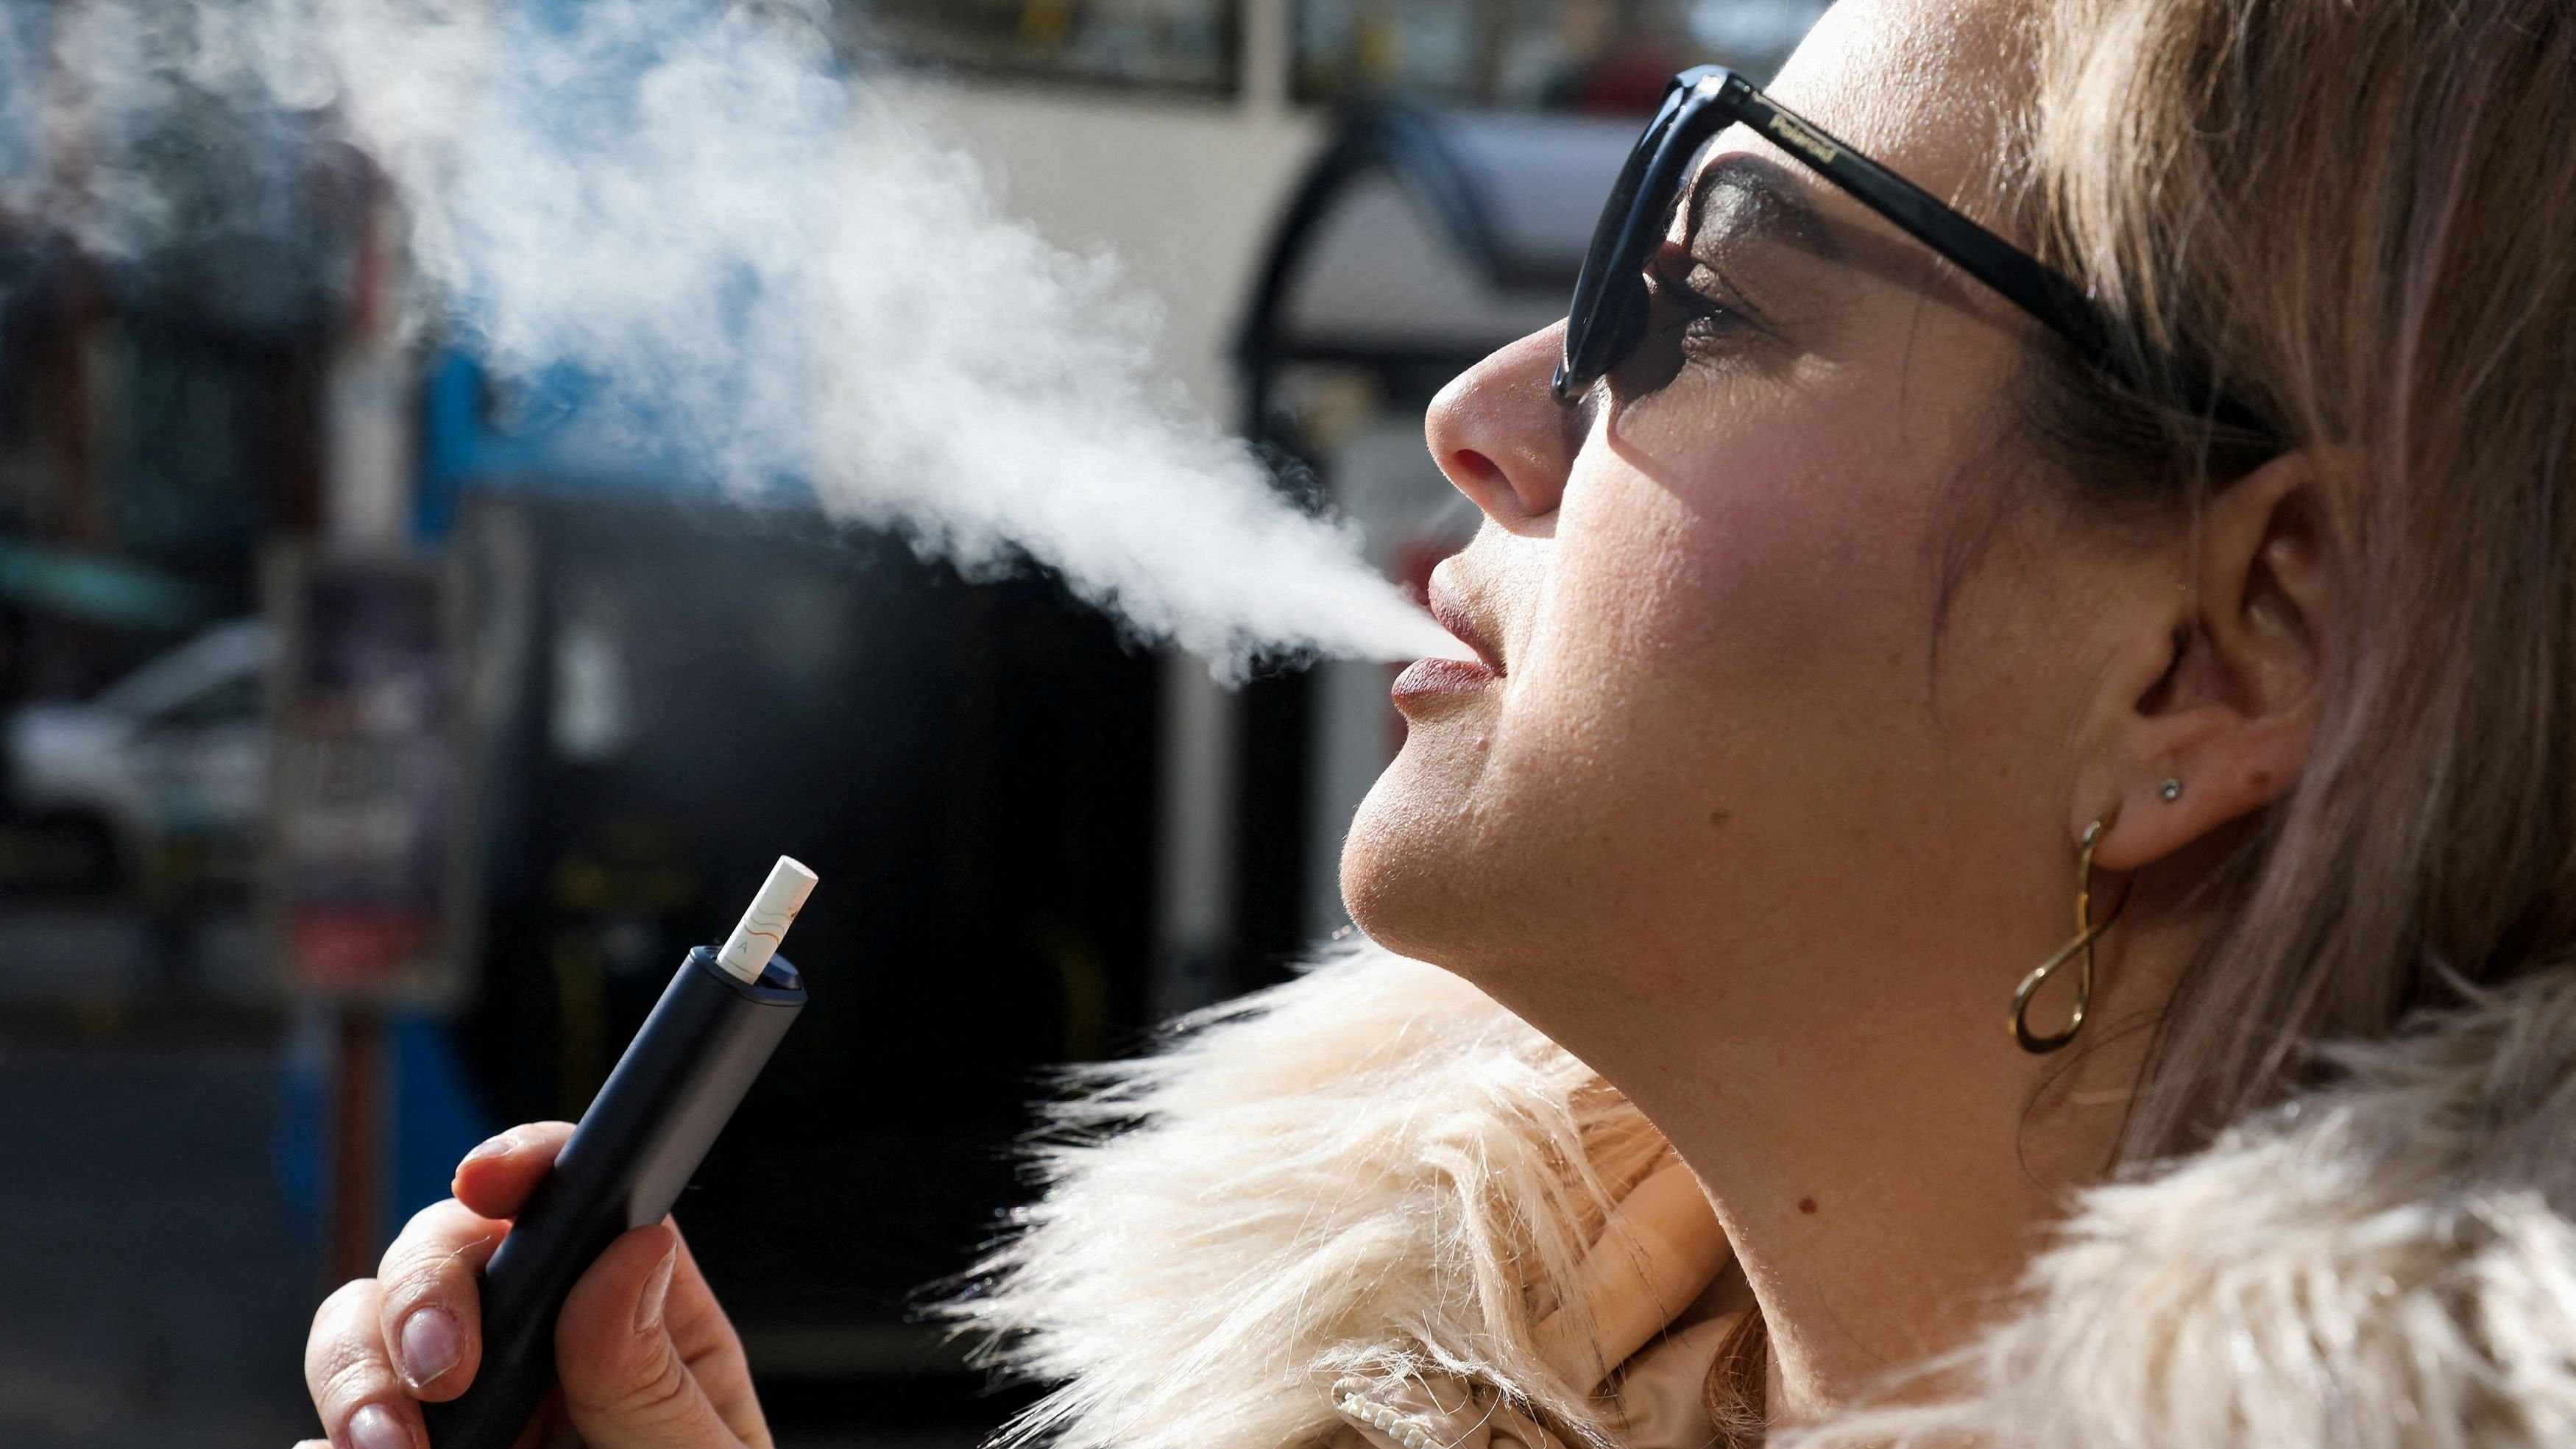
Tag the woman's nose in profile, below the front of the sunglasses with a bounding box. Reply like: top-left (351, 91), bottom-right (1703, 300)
top-left (1422, 322), bottom-right (1585, 533)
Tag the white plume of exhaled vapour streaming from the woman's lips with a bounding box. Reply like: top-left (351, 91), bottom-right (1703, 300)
top-left (15, 0), bottom-right (1456, 672)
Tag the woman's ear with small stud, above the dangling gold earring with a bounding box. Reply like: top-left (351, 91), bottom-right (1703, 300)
top-left (2074, 448), bottom-right (2354, 870)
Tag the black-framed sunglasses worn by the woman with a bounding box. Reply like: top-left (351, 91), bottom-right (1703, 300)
top-left (1554, 64), bottom-right (2272, 438)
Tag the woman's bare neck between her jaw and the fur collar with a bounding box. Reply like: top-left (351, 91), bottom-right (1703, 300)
top-left (1515, 916), bottom-right (2179, 1426)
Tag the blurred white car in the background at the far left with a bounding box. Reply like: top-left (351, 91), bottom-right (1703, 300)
top-left (8, 620), bottom-right (271, 875)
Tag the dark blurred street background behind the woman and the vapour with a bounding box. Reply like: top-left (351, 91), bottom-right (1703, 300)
top-left (0, 0), bottom-right (1822, 1449)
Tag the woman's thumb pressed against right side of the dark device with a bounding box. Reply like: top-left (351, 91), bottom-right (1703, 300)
top-left (554, 1222), bottom-right (740, 1449)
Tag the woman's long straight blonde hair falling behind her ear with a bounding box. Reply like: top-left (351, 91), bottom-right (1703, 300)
top-left (2020, 0), bottom-right (2576, 1161)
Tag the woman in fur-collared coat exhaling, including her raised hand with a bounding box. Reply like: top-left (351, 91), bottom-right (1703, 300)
top-left (292, 0), bottom-right (2576, 1449)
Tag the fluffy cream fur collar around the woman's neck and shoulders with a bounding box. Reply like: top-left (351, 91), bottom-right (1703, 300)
top-left (951, 947), bottom-right (2576, 1449)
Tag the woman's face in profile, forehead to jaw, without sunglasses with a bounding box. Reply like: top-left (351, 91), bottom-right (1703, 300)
top-left (1342, 0), bottom-right (2095, 1045)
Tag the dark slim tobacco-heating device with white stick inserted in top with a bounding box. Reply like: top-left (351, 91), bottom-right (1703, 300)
top-left (420, 857), bottom-right (814, 1449)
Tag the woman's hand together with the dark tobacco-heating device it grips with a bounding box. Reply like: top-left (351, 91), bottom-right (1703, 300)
top-left (307, 857), bottom-right (814, 1449)
